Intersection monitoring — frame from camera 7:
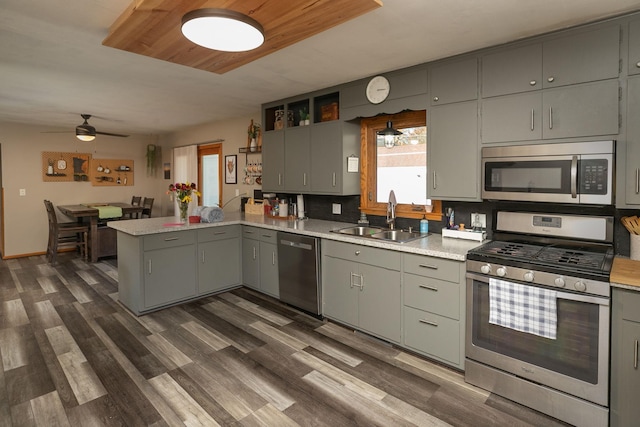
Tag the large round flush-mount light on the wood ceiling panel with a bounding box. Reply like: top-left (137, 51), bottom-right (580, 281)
top-left (182, 9), bottom-right (264, 52)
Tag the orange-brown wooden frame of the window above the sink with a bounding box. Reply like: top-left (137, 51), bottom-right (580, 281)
top-left (360, 110), bottom-right (442, 221)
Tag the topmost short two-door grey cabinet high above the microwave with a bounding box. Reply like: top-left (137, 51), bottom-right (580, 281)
top-left (482, 25), bottom-right (624, 98)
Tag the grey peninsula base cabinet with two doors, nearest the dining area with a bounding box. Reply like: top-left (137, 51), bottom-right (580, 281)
top-left (118, 225), bottom-right (240, 315)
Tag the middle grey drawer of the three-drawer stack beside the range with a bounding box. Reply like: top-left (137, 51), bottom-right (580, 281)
top-left (403, 273), bottom-right (460, 319)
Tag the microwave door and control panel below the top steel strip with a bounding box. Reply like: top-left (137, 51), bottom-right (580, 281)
top-left (482, 154), bottom-right (613, 205)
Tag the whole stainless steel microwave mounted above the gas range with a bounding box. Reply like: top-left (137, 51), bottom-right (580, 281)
top-left (482, 141), bottom-right (616, 205)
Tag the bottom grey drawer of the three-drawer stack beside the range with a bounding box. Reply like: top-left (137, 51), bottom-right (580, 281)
top-left (404, 307), bottom-right (461, 365)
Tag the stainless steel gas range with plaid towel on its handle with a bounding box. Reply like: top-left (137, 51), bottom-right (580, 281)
top-left (465, 211), bottom-right (613, 426)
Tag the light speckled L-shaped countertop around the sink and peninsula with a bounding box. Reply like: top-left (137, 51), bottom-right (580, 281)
top-left (107, 213), bottom-right (482, 261)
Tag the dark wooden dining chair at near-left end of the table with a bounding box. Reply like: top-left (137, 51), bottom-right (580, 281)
top-left (44, 200), bottom-right (89, 264)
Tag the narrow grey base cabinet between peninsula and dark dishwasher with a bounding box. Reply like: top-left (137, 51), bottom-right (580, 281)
top-left (242, 226), bottom-right (280, 298)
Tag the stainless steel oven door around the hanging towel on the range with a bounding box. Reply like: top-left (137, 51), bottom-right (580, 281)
top-left (465, 273), bottom-right (610, 406)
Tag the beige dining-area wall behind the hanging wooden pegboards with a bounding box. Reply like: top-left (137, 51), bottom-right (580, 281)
top-left (0, 110), bottom-right (260, 258)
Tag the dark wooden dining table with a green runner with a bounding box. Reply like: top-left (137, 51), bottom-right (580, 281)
top-left (58, 202), bottom-right (144, 262)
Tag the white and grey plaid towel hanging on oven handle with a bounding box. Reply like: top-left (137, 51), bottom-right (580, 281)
top-left (489, 279), bottom-right (558, 340)
